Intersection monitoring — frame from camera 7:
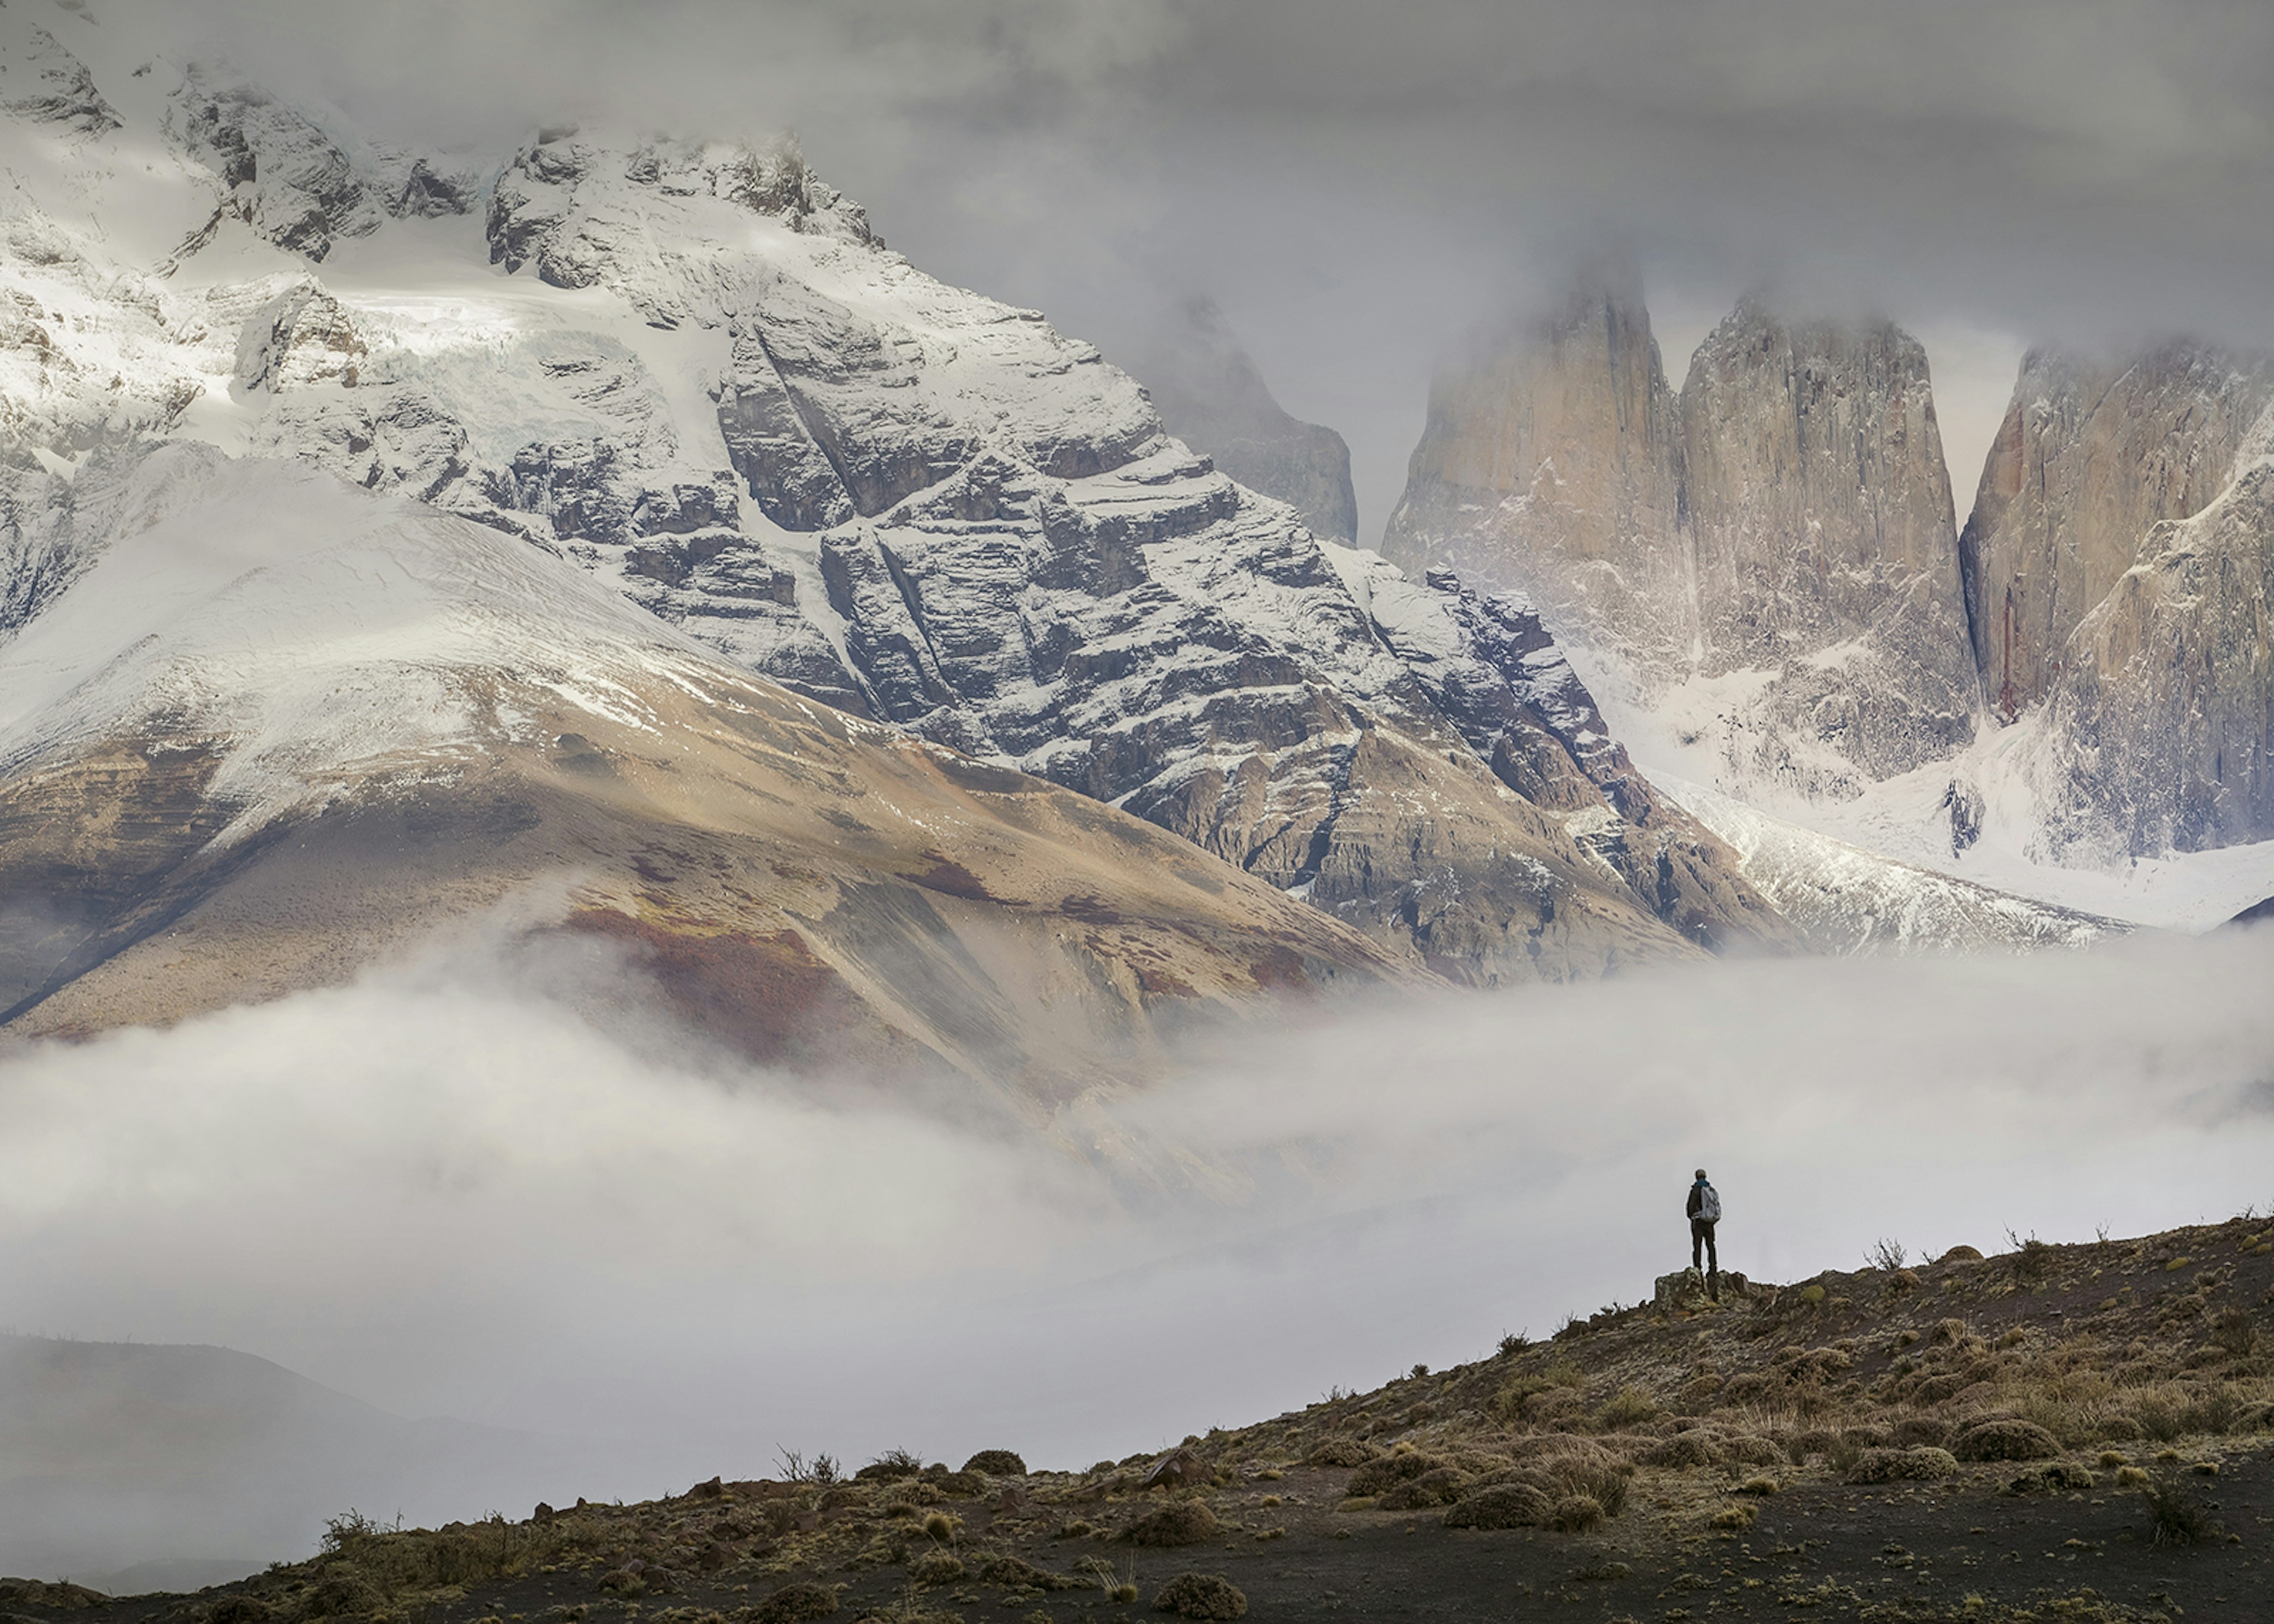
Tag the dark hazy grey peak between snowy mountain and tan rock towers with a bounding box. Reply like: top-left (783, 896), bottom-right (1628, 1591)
top-left (1128, 298), bottom-right (1357, 544)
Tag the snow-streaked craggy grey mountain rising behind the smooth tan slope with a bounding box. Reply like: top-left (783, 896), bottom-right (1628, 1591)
top-left (0, 22), bottom-right (1785, 980)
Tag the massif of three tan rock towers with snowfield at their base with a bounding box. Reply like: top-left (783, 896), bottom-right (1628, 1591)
top-left (1385, 266), bottom-right (2274, 905)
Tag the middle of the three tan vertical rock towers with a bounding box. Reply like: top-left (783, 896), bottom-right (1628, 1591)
top-left (1681, 300), bottom-right (1974, 778)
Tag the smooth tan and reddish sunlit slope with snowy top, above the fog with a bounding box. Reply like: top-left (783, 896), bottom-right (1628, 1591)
top-left (0, 446), bottom-right (1410, 1096)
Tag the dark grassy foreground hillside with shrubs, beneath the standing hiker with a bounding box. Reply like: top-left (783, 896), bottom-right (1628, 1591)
top-left (22, 1219), bottom-right (2274, 1624)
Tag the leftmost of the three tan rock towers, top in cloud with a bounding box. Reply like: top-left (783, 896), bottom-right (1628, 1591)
top-left (1383, 275), bottom-right (1697, 668)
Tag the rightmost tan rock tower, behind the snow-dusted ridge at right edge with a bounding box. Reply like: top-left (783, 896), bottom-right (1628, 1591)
top-left (1960, 343), bottom-right (2274, 721)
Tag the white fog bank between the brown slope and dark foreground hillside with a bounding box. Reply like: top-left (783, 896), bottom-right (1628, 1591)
top-left (0, 932), bottom-right (2274, 1558)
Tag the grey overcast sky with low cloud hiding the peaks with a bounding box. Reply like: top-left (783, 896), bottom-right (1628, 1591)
top-left (129, 0), bottom-right (2274, 535)
